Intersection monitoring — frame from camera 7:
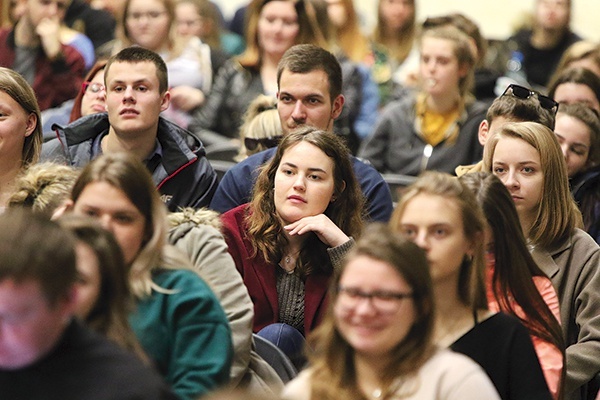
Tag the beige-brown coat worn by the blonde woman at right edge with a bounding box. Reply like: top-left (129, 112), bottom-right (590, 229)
top-left (532, 229), bottom-right (600, 399)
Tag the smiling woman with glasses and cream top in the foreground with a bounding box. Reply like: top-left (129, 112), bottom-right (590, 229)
top-left (283, 225), bottom-right (499, 400)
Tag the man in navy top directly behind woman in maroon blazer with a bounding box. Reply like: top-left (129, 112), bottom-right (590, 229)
top-left (210, 44), bottom-right (393, 222)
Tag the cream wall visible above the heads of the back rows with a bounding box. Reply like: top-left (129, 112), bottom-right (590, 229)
top-left (213, 0), bottom-right (600, 41)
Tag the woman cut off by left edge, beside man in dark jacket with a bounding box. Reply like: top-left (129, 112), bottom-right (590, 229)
top-left (0, 67), bottom-right (43, 209)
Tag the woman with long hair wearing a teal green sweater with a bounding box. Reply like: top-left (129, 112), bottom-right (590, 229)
top-left (70, 153), bottom-right (232, 400)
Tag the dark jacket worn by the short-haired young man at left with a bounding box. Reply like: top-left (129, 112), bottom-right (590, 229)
top-left (40, 113), bottom-right (217, 211)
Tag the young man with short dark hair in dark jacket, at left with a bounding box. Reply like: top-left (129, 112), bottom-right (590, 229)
top-left (42, 47), bottom-right (217, 211)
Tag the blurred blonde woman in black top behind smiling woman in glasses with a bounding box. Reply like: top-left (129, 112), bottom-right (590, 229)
top-left (390, 171), bottom-right (552, 400)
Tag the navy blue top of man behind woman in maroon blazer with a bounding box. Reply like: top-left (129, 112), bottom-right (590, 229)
top-left (210, 148), bottom-right (393, 222)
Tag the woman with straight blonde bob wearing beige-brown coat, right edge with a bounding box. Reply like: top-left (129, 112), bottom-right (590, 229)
top-left (483, 122), bottom-right (600, 399)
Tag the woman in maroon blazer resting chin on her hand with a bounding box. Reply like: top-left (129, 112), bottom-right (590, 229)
top-left (222, 126), bottom-right (364, 362)
